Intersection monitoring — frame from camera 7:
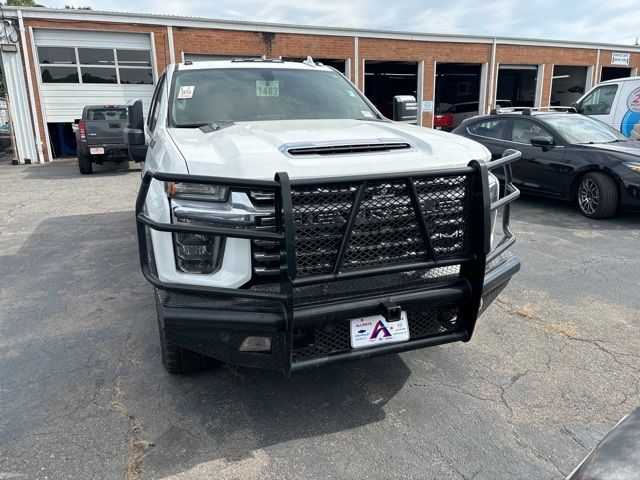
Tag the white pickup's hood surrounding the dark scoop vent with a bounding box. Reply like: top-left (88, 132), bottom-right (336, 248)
top-left (169, 120), bottom-right (490, 180)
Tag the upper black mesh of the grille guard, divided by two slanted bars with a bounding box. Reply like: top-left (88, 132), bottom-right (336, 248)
top-left (292, 175), bottom-right (472, 277)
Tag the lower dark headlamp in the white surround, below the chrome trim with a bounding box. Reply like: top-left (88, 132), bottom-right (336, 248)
top-left (173, 233), bottom-right (222, 274)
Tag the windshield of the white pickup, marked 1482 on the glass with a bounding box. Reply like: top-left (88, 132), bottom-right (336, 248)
top-left (170, 68), bottom-right (380, 127)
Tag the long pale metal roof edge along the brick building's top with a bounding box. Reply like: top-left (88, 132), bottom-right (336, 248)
top-left (2, 6), bottom-right (640, 52)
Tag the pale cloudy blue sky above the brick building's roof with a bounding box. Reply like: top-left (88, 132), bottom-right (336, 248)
top-left (37, 0), bottom-right (640, 45)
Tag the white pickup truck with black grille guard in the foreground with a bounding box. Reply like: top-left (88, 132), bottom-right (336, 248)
top-left (125, 58), bottom-right (520, 374)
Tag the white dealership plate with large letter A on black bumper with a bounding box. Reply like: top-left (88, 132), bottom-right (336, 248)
top-left (351, 312), bottom-right (409, 348)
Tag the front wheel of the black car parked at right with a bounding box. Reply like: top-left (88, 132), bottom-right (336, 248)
top-left (578, 172), bottom-right (618, 218)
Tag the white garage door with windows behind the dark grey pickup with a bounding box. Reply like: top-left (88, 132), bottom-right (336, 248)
top-left (34, 29), bottom-right (155, 123)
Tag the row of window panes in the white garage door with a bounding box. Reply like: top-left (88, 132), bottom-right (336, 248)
top-left (38, 47), bottom-right (153, 85)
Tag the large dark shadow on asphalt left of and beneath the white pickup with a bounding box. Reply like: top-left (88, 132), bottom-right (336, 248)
top-left (0, 209), bottom-right (410, 477)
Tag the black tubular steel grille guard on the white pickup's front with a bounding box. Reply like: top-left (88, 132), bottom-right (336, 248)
top-left (136, 150), bottom-right (520, 366)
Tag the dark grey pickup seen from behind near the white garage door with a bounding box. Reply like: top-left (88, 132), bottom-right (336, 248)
top-left (76, 105), bottom-right (130, 174)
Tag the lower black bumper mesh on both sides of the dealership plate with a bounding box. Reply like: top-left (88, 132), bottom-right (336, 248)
top-left (292, 306), bottom-right (458, 362)
